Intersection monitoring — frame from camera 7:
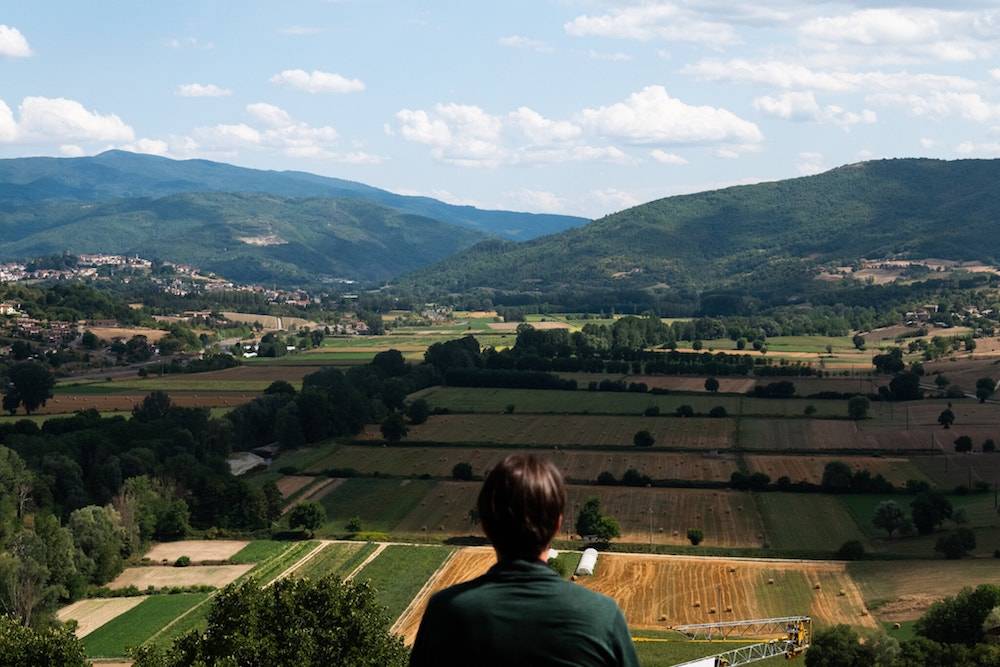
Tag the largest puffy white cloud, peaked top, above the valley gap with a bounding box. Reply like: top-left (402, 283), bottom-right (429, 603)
top-left (581, 86), bottom-right (764, 146)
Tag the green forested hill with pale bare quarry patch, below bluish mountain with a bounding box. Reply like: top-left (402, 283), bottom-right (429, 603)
top-left (0, 193), bottom-right (483, 284)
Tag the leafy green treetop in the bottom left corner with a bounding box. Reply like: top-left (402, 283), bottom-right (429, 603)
top-left (0, 614), bottom-right (90, 667)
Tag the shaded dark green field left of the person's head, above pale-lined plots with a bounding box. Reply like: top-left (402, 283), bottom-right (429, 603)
top-left (320, 479), bottom-right (434, 535)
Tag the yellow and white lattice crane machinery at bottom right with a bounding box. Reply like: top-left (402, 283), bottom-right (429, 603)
top-left (672, 616), bottom-right (812, 667)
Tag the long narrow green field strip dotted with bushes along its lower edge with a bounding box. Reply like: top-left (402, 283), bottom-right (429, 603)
top-left (411, 387), bottom-right (847, 417)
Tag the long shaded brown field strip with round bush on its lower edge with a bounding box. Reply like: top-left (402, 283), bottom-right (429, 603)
top-left (376, 414), bottom-right (736, 449)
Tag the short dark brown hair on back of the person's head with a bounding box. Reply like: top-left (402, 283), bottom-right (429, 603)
top-left (478, 454), bottom-right (566, 560)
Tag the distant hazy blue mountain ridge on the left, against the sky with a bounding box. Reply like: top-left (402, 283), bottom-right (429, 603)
top-left (0, 151), bottom-right (587, 240)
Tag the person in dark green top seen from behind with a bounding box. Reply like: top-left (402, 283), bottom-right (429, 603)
top-left (410, 454), bottom-right (639, 667)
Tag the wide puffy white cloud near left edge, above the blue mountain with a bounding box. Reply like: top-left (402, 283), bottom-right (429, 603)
top-left (17, 97), bottom-right (135, 142)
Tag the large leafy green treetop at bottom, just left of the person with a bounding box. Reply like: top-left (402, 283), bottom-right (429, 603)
top-left (135, 576), bottom-right (407, 667)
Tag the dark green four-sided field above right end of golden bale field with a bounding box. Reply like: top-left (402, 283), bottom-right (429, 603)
top-left (754, 493), bottom-right (867, 554)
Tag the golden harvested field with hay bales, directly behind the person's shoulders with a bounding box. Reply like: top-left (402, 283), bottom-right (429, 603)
top-left (396, 548), bottom-right (876, 643)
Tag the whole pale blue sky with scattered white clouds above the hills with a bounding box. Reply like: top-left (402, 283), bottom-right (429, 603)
top-left (0, 0), bottom-right (1000, 217)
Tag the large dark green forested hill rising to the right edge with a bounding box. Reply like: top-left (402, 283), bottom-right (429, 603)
top-left (404, 159), bottom-right (1000, 298)
